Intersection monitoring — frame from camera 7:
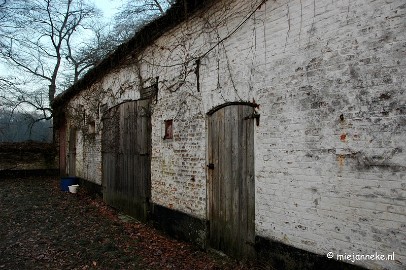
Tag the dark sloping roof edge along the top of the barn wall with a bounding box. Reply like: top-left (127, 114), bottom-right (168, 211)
top-left (51, 0), bottom-right (211, 109)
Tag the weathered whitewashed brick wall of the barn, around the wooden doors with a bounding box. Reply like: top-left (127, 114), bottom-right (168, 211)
top-left (65, 0), bottom-right (406, 269)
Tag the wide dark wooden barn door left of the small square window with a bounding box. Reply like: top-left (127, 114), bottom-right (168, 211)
top-left (102, 100), bottom-right (151, 220)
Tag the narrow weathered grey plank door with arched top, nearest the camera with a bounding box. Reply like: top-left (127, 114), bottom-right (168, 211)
top-left (208, 105), bottom-right (255, 258)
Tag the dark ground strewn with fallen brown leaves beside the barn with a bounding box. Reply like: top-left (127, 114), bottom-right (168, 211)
top-left (0, 177), bottom-right (254, 270)
